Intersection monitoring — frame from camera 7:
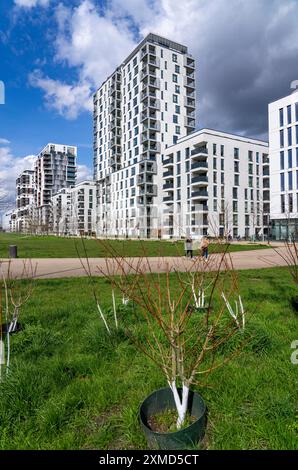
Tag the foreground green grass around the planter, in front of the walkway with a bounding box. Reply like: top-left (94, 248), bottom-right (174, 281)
top-left (0, 268), bottom-right (298, 449)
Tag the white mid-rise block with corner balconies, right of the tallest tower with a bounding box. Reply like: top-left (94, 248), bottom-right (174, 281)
top-left (158, 129), bottom-right (270, 238)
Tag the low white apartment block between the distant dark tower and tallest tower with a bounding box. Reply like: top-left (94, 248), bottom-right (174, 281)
top-left (51, 181), bottom-right (96, 236)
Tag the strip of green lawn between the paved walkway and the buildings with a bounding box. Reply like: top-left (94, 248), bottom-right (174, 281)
top-left (0, 233), bottom-right (268, 258)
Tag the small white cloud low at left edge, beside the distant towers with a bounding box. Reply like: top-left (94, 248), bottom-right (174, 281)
top-left (0, 139), bottom-right (36, 207)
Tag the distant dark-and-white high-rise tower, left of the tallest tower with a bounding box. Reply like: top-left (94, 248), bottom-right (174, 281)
top-left (34, 144), bottom-right (77, 232)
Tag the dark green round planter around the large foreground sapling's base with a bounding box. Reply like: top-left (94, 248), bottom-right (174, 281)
top-left (139, 388), bottom-right (207, 450)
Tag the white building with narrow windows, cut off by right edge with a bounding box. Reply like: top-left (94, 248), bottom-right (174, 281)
top-left (268, 91), bottom-right (298, 240)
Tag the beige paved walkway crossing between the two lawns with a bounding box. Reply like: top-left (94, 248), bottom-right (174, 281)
top-left (2, 247), bottom-right (286, 279)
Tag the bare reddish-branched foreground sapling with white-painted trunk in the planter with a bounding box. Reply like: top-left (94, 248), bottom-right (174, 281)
top-left (98, 241), bottom-right (245, 429)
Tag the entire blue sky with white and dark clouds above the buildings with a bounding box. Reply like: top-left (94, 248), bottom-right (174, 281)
top-left (0, 0), bottom-right (298, 209)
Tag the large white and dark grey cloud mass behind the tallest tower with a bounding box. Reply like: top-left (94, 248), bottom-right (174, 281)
top-left (29, 0), bottom-right (298, 136)
